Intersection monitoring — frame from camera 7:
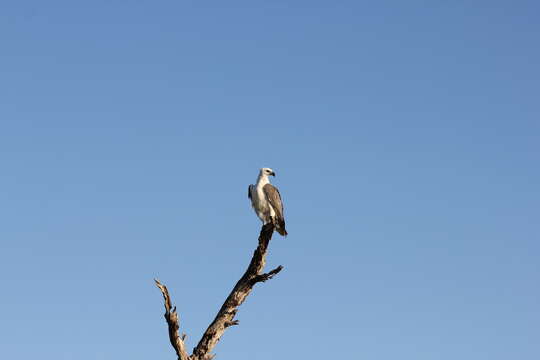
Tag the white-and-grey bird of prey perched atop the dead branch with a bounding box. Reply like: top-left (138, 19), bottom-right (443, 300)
top-left (248, 168), bottom-right (287, 236)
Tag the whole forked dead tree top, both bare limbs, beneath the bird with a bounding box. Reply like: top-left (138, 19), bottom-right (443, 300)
top-left (156, 224), bottom-right (283, 360)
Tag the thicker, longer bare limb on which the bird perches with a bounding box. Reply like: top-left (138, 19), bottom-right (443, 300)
top-left (192, 224), bottom-right (283, 360)
